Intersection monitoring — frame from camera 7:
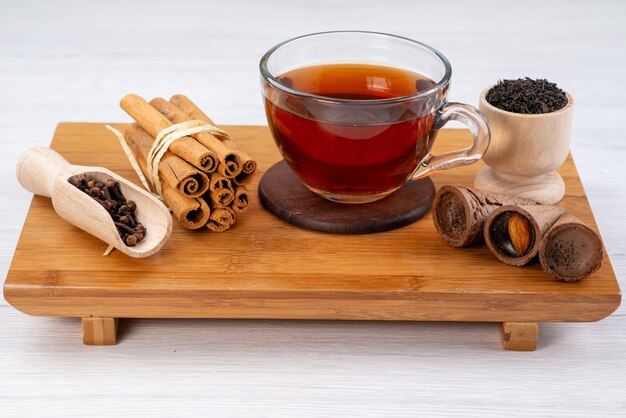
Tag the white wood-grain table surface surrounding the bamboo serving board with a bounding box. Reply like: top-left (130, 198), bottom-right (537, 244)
top-left (0, 0), bottom-right (626, 418)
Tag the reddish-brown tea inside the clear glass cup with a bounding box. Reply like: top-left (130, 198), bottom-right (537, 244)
top-left (265, 64), bottom-right (435, 196)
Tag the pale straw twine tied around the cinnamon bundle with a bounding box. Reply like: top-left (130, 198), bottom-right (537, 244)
top-left (105, 120), bottom-right (232, 200)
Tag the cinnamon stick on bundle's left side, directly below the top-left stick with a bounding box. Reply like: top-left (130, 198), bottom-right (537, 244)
top-left (124, 123), bottom-right (209, 198)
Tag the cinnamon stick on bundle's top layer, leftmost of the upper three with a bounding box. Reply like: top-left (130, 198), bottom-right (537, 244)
top-left (120, 94), bottom-right (218, 173)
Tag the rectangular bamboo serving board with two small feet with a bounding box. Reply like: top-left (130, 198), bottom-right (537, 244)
top-left (4, 123), bottom-right (621, 350)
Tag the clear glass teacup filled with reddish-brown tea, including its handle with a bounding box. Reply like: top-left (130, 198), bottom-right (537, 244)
top-left (260, 31), bottom-right (490, 203)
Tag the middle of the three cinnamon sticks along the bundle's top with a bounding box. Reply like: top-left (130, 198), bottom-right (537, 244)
top-left (150, 97), bottom-right (243, 178)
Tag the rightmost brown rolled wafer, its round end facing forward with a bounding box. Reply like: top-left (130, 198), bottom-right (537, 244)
top-left (539, 214), bottom-right (604, 282)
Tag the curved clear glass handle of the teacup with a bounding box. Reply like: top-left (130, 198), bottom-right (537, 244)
top-left (411, 103), bottom-right (491, 180)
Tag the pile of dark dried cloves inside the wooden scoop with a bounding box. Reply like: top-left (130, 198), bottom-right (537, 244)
top-left (68, 174), bottom-right (146, 247)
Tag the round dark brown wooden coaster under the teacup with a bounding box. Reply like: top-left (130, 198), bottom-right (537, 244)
top-left (259, 161), bottom-right (435, 234)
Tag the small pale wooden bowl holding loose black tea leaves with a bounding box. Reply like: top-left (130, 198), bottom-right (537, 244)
top-left (474, 86), bottom-right (574, 205)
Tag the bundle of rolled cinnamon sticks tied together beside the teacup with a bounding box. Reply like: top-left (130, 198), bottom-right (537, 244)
top-left (120, 94), bottom-right (256, 232)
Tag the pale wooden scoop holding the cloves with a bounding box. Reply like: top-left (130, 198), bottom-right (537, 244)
top-left (17, 147), bottom-right (172, 258)
